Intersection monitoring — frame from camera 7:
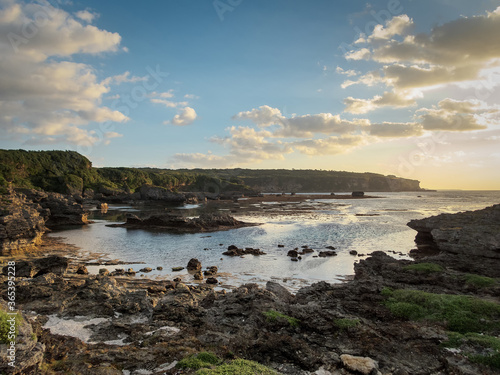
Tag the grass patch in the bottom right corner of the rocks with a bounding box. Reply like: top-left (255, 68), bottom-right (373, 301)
top-left (443, 332), bottom-right (500, 369)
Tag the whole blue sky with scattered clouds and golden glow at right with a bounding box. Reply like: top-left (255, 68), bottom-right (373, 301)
top-left (0, 0), bottom-right (500, 190)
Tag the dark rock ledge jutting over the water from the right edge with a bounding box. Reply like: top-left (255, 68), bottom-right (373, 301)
top-left (408, 204), bottom-right (500, 259)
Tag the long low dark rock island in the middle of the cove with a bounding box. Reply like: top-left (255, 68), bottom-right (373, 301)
top-left (108, 214), bottom-right (260, 233)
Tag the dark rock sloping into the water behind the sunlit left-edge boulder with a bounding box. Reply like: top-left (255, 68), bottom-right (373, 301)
top-left (16, 189), bottom-right (89, 228)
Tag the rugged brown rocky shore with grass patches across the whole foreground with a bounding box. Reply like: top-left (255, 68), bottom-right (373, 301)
top-left (0, 200), bottom-right (500, 375)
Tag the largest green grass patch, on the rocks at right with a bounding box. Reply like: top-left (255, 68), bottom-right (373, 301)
top-left (382, 288), bottom-right (500, 333)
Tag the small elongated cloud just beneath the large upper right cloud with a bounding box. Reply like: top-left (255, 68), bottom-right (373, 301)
top-left (344, 92), bottom-right (417, 114)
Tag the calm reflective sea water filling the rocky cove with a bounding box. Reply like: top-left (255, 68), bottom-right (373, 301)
top-left (50, 191), bottom-right (500, 290)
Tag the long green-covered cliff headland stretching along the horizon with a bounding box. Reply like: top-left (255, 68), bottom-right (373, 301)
top-left (0, 150), bottom-right (420, 194)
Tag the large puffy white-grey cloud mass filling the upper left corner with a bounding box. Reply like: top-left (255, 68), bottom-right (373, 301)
top-left (0, 0), bottom-right (128, 145)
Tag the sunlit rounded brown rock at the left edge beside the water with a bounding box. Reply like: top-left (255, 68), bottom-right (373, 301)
top-left (0, 193), bottom-right (47, 256)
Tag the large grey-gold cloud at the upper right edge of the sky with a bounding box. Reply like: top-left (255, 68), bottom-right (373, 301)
top-left (344, 7), bottom-right (500, 89)
